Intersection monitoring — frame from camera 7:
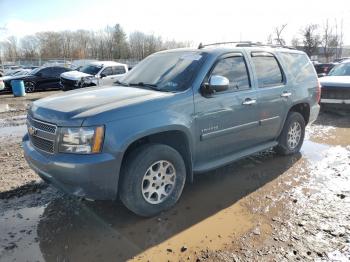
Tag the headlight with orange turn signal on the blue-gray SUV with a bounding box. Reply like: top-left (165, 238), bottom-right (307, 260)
top-left (58, 126), bottom-right (104, 154)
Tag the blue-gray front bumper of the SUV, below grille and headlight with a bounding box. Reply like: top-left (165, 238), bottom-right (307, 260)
top-left (22, 135), bottom-right (121, 200)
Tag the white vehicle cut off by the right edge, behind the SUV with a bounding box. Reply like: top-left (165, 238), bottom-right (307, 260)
top-left (320, 61), bottom-right (350, 109)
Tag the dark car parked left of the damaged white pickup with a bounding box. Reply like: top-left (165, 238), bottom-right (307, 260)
top-left (4, 66), bottom-right (72, 93)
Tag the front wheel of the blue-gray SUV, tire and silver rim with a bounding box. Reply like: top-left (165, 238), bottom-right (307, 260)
top-left (120, 144), bottom-right (186, 217)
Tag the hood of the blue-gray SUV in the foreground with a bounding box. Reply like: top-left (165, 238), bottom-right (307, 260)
top-left (29, 86), bottom-right (174, 126)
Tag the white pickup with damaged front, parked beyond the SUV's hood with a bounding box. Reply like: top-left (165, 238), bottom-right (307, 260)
top-left (61, 61), bottom-right (128, 91)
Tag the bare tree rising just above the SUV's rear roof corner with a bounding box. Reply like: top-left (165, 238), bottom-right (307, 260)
top-left (301, 24), bottom-right (321, 57)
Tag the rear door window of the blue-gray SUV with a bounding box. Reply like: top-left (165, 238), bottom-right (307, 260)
top-left (252, 52), bottom-right (283, 87)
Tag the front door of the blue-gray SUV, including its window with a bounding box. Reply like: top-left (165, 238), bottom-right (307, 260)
top-left (194, 53), bottom-right (259, 166)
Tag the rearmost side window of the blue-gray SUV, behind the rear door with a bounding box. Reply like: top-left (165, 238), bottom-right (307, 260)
top-left (279, 53), bottom-right (316, 83)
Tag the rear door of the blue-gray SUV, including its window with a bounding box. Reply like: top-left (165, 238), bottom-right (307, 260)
top-left (250, 51), bottom-right (292, 142)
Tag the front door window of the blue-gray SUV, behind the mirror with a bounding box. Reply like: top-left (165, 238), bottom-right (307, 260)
top-left (211, 56), bottom-right (250, 90)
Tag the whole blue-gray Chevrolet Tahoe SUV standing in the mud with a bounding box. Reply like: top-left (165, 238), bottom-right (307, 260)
top-left (23, 45), bottom-right (320, 216)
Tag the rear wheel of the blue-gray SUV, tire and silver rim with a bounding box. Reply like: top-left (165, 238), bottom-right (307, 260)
top-left (275, 112), bottom-right (305, 155)
